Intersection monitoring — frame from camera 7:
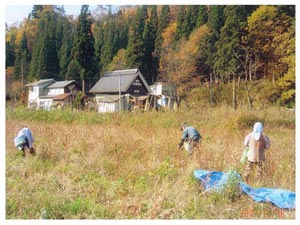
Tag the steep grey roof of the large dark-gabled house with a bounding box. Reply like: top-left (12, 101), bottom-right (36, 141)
top-left (90, 69), bottom-right (151, 93)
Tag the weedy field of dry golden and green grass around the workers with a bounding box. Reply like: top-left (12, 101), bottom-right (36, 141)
top-left (5, 106), bottom-right (296, 219)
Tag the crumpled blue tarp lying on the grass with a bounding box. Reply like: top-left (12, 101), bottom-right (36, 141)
top-left (194, 170), bottom-right (296, 209)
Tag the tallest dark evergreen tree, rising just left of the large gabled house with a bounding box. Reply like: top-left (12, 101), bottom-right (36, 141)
top-left (67, 5), bottom-right (97, 93)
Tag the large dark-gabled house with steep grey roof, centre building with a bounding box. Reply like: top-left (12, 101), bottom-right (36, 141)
top-left (90, 69), bottom-right (151, 113)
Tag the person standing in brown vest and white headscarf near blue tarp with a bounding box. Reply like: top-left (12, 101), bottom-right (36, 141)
top-left (244, 122), bottom-right (270, 180)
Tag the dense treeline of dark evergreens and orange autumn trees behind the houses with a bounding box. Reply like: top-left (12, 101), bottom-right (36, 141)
top-left (6, 5), bottom-right (295, 107)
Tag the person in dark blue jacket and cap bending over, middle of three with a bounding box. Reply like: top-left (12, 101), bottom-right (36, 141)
top-left (178, 122), bottom-right (201, 155)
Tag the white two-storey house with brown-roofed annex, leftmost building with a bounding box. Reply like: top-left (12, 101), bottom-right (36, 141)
top-left (25, 79), bottom-right (80, 110)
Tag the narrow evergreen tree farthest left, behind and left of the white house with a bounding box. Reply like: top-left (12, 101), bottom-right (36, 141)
top-left (14, 32), bottom-right (30, 82)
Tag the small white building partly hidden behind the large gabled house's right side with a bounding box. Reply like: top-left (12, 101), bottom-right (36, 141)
top-left (150, 82), bottom-right (177, 109)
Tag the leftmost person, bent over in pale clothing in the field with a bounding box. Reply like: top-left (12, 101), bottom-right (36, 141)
top-left (14, 127), bottom-right (35, 156)
